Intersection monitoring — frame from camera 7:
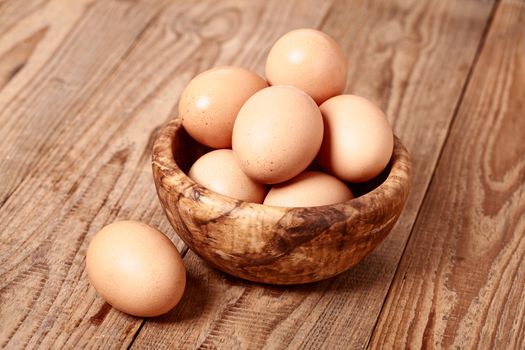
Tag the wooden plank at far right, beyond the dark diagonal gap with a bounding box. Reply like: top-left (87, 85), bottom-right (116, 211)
top-left (371, 0), bottom-right (525, 349)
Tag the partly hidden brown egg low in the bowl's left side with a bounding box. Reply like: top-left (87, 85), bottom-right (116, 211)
top-left (189, 149), bottom-right (266, 203)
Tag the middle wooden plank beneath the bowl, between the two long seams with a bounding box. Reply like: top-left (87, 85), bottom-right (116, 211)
top-left (133, 1), bottom-right (493, 349)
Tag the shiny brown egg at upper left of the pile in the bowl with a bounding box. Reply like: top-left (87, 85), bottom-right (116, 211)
top-left (179, 67), bottom-right (268, 148)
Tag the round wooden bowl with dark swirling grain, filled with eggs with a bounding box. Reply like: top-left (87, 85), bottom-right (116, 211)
top-left (153, 119), bottom-right (411, 284)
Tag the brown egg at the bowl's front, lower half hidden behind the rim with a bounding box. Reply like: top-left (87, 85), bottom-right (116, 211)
top-left (264, 171), bottom-right (354, 207)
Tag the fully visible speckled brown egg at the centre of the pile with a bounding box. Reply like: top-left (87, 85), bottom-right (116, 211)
top-left (233, 85), bottom-right (323, 184)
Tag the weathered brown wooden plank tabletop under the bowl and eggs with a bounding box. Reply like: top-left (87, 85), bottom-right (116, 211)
top-left (0, 0), bottom-right (525, 349)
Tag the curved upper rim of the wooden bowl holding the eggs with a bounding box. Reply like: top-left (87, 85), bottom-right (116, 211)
top-left (152, 117), bottom-right (411, 215)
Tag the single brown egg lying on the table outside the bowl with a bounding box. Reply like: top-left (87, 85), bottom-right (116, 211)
top-left (86, 221), bottom-right (186, 317)
